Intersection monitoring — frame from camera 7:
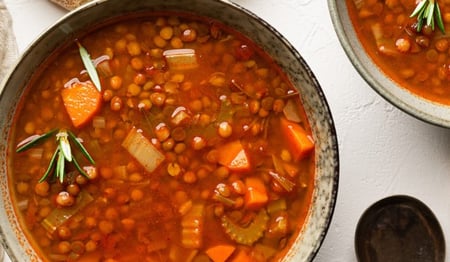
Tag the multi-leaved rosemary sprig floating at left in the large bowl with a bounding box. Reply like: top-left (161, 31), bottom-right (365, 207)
top-left (16, 129), bottom-right (95, 183)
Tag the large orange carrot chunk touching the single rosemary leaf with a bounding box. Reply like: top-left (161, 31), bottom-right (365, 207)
top-left (61, 81), bottom-right (102, 127)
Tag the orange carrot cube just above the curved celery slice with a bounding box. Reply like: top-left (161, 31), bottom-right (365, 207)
top-left (245, 177), bottom-right (269, 209)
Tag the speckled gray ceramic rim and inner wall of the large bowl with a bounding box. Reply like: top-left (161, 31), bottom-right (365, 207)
top-left (0, 0), bottom-right (339, 261)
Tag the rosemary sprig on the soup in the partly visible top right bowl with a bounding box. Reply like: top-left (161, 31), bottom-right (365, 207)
top-left (410, 0), bottom-right (445, 34)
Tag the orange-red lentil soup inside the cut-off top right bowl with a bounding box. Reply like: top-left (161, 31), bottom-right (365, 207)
top-left (346, 0), bottom-right (450, 104)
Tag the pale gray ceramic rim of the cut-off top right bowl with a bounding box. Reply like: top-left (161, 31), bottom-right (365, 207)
top-left (328, 0), bottom-right (450, 127)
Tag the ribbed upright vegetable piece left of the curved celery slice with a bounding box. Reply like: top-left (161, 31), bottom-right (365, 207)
top-left (181, 203), bottom-right (205, 248)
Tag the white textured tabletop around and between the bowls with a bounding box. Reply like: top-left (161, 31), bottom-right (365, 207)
top-left (4, 0), bottom-right (450, 262)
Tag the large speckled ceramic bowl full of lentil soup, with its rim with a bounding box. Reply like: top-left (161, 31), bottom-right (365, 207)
top-left (0, 0), bottom-right (338, 261)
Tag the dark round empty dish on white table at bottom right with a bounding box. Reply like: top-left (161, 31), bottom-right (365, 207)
top-left (355, 195), bottom-right (445, 262)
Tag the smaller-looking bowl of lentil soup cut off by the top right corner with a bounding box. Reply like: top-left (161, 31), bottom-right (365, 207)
top-left (328, 0), bottom-right (450, 127)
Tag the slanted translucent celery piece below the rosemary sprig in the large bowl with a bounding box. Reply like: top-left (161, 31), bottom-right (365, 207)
top-left (41, 190), bottom-right (94, 234)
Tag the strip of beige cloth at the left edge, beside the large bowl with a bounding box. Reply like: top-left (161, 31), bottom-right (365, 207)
top-left (0, 0), bottom-right (18, 85)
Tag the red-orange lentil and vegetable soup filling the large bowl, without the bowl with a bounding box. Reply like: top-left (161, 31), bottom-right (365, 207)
top-left (10, 15), bottom-right (315, 262)
